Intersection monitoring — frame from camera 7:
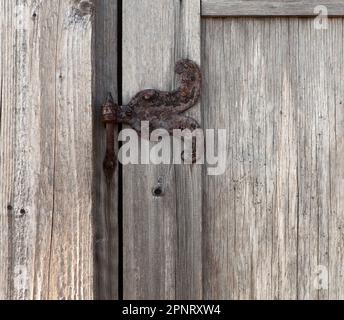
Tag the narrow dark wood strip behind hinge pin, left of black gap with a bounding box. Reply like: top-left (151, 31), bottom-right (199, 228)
top-left (94, 0), bottom-right (119, 299)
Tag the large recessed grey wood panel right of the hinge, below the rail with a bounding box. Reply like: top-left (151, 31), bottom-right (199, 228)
top-left (202, 18), bottom-right (344, 299)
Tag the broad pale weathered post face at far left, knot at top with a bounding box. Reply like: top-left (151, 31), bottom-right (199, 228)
top-left (0, 0), bottom-right (94, 299)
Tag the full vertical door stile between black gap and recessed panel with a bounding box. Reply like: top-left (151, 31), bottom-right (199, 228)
top-left (123, 0), bottom-right (202, 299)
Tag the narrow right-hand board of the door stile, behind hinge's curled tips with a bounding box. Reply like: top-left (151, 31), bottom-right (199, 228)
top-left (174, 0), bottom-right (203, 299)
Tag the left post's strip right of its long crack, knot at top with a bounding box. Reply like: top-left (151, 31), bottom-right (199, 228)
top-left (45, 1), bottom-right (94, 299)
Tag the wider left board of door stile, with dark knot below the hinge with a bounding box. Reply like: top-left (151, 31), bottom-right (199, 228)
top-left (122, 0), bottom-right (176, 299)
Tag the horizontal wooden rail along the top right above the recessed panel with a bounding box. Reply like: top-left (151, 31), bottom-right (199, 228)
top-left (201, 0), bottom-right (344, 17)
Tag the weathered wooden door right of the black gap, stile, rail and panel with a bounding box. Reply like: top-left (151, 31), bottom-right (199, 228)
top-left (123, 0), bottom-right (344, 299)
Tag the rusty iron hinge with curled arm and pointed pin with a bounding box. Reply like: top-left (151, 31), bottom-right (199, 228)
top-left (102, 59), bottom-right (202, 179)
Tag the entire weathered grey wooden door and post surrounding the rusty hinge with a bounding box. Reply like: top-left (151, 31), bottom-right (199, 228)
top-left (0, 0), bottom-right (344, 299)
